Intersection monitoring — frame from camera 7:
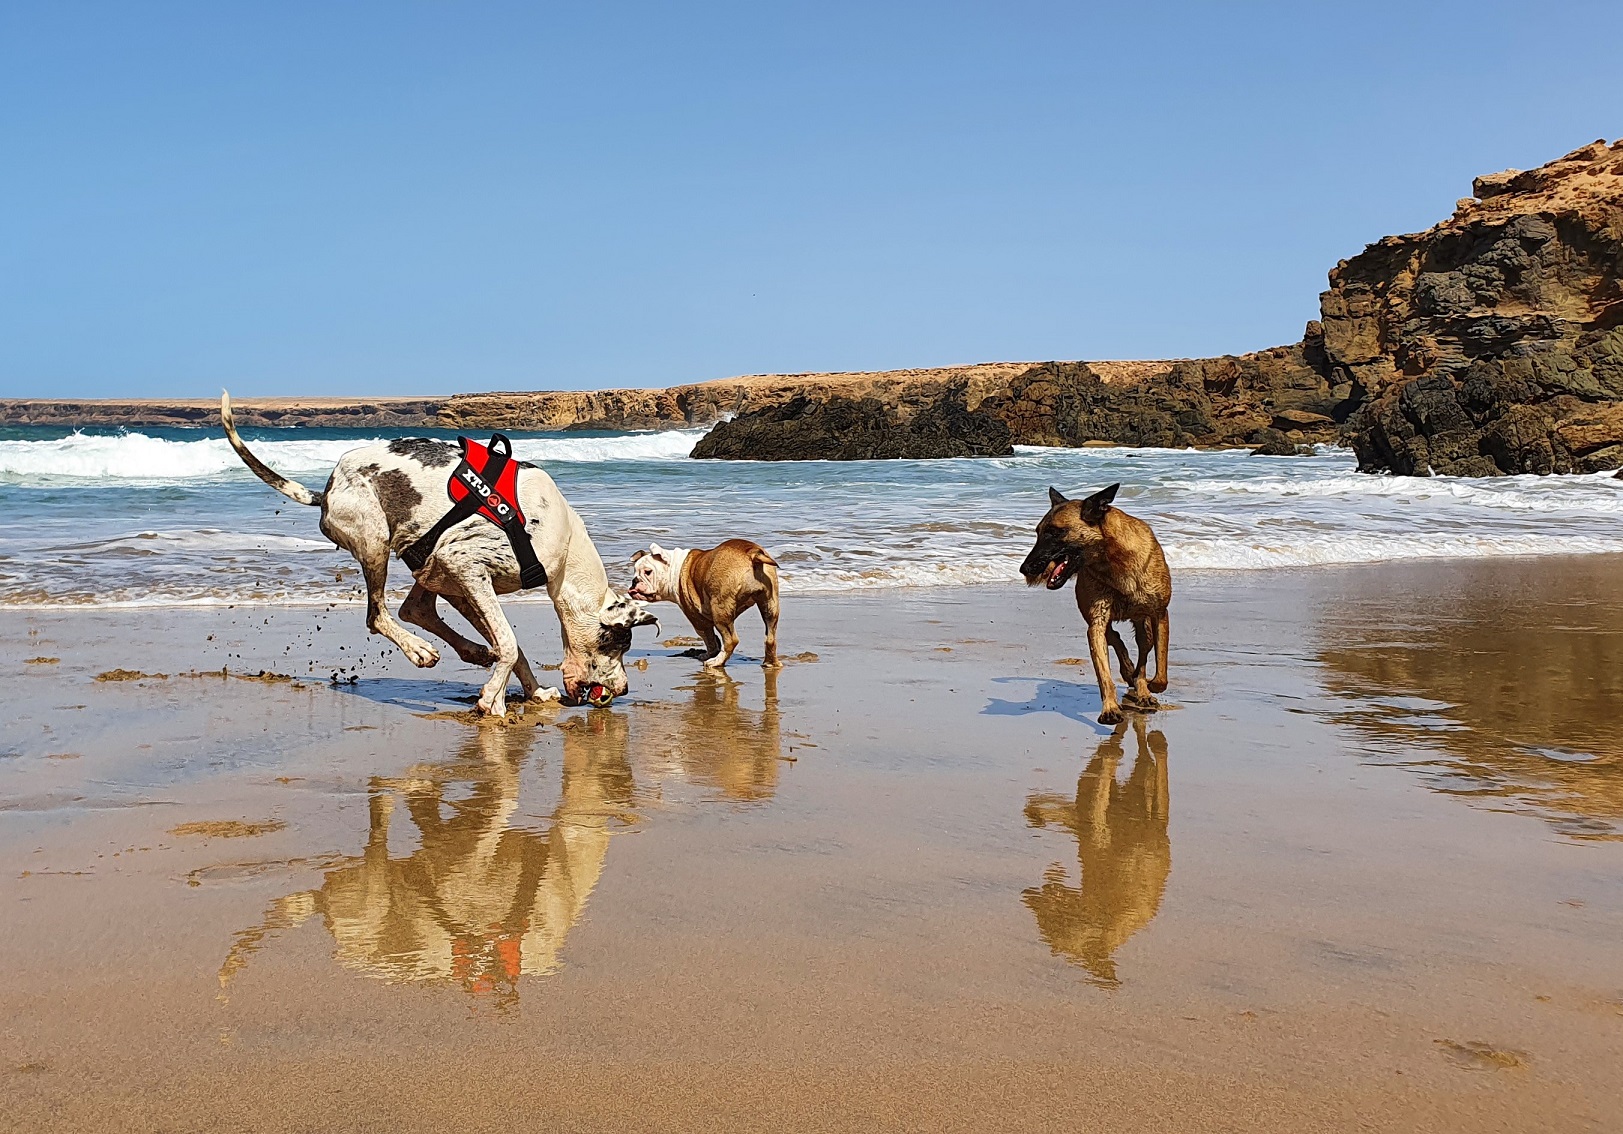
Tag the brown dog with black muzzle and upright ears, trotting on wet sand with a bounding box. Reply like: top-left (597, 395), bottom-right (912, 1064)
top-left (1019, 483), bottom-right (1172, 725)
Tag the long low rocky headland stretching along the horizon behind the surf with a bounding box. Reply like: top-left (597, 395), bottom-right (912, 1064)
top-left (0, 352), bottom-right (1347, 459)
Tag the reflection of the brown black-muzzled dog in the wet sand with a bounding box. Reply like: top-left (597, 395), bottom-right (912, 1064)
top-left (1021, 717), bottom-right (1172, 988)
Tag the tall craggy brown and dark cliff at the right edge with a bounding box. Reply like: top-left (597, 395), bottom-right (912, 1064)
top-left (1319, 141), bottom-right (1623, 475)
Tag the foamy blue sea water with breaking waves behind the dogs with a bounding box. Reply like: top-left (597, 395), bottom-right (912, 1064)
top-left (0, 428), bottom-right (1623, 607)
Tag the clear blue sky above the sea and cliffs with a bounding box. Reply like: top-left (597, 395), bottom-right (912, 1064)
top-left (0, 0), bottom-right (1623, 397)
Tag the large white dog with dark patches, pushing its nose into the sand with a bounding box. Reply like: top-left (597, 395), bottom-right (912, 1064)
top-left (219, 393), bottom-right (654, 717)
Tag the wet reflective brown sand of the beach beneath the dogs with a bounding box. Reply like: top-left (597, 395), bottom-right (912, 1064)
top-left (0, 556), bottom-right (1623, 1132)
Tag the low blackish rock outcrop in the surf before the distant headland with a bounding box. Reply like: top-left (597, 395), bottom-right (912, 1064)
top-left (691, 386), bottom-right (1013, 461)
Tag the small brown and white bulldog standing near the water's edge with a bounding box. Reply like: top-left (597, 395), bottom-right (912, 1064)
top-left (628, 540), bottom-right (777, 670)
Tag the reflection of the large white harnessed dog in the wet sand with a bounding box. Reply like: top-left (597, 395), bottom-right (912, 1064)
top-left (219, 711), bottom-right (633, 1004)
